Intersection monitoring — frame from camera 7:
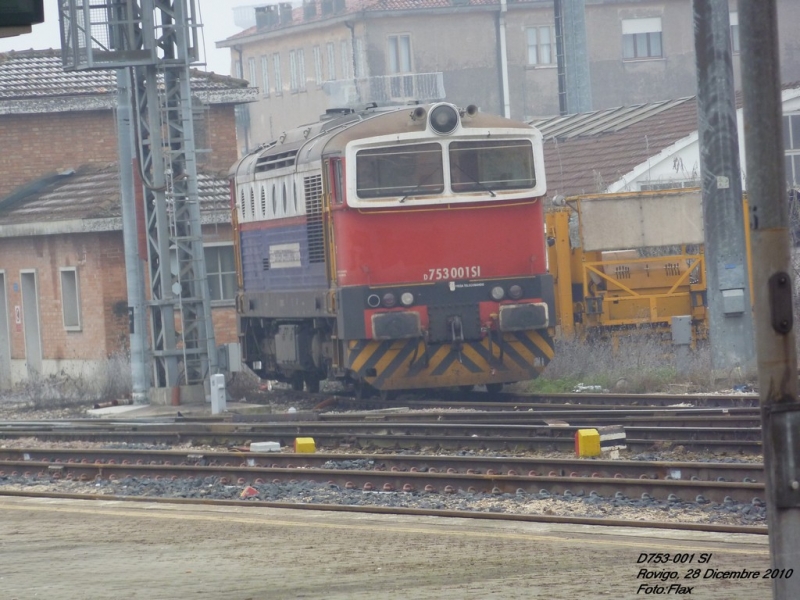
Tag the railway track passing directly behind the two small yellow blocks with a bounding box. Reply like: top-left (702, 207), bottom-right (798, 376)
top-left (0, 417), bottom-right (761, 453)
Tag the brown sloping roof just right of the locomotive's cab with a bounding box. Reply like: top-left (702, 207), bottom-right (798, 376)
top-left (532, 97), bottom-right (697, 198)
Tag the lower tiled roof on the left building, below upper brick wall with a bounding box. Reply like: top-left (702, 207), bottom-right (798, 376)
top-left (0, 165), bottom-right (230, 229)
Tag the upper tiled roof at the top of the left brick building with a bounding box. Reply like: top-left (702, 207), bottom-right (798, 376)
top-left (0, 50), bottom-right (253, 108)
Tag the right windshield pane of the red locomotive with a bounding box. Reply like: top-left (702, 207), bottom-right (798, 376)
top-left (450, 140), bottom-right (536, 192)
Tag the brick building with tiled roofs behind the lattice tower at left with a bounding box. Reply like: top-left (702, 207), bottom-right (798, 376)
top-left (0, 50), bottom-right (253, 389)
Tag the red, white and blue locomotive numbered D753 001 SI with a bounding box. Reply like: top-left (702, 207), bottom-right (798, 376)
top-left (231, 103), bottom-right (554, 397)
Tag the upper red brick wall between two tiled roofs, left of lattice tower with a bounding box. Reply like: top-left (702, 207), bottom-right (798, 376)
top-left (0, 108), bottom-right (117, 198)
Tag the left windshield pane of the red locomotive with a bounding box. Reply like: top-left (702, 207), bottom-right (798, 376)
top-left (356, 143), bottom-right (444, 198)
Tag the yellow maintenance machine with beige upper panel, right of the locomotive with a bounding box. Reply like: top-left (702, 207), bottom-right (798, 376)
top-left (546, 189), bottom-right (750, 340)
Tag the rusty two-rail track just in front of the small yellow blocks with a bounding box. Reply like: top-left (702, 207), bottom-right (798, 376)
top-left (0, 448), bottom-right (764, 504)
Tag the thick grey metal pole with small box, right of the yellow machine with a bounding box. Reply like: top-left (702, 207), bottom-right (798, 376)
top-left (694, 0), bottom-right (755, 379)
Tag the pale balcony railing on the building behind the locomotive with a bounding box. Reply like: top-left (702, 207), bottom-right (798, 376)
top-left (323, 73), bottom-right (445, 107)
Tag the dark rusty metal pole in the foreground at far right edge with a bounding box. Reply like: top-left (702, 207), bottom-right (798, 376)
top-left (739, 0), bottom-right (800, 600)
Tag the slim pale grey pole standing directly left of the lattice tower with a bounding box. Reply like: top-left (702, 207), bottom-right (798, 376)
top-left (117, 69), bottom-right (150, 404)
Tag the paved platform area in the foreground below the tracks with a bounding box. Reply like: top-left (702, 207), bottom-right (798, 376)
top-left (0, 496), bottom-right (771, 600)
